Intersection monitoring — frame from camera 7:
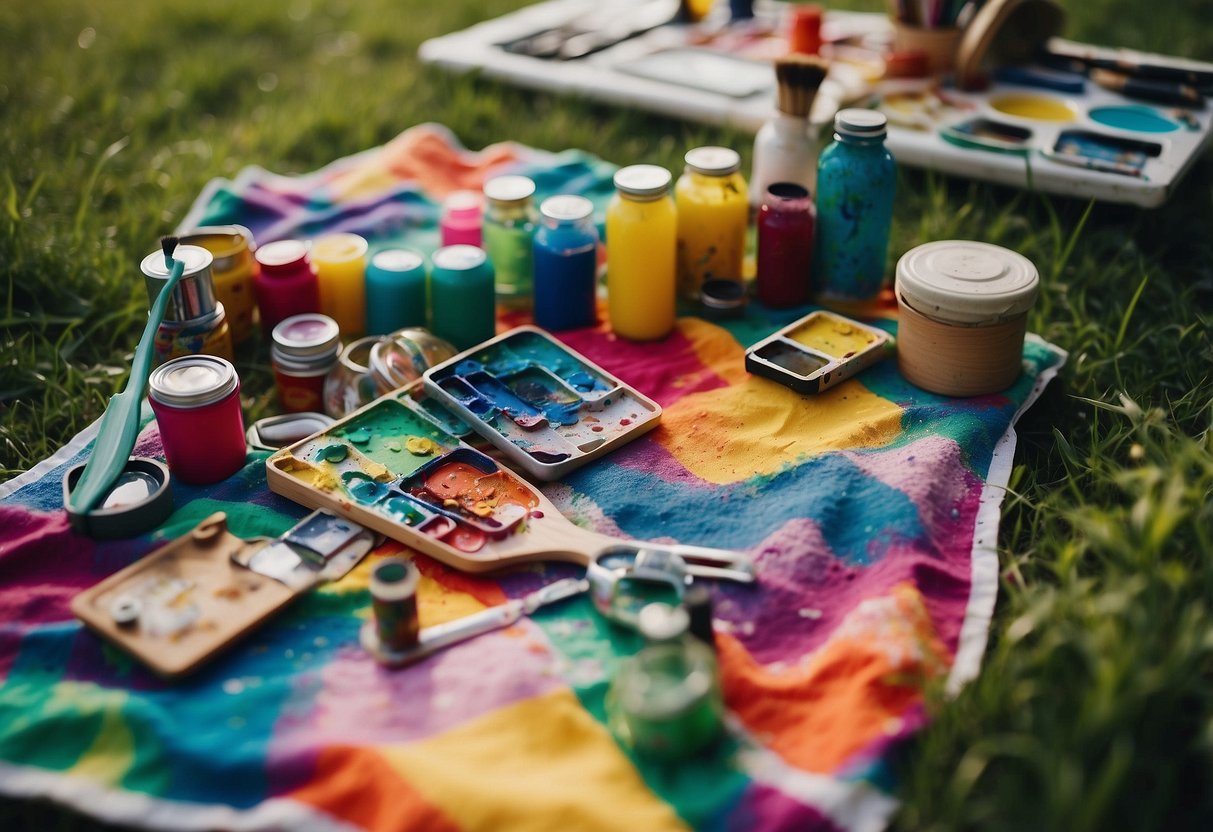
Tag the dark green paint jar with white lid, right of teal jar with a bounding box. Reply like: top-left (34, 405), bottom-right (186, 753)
top-left (429, 246), bottom-right (497, 349)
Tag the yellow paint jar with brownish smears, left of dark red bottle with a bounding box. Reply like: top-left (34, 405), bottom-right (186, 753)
top-left (674, 147), bottom-right (750, 301)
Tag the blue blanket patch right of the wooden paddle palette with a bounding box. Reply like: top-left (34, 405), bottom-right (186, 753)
top-left (566, 454), bottom-right (927, 565)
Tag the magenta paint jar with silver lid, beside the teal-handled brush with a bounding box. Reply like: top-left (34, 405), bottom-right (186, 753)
top-left (148, 355), bottom-right (245, 485)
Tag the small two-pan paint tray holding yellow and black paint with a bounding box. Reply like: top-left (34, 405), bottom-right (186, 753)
top-left (746, 309), bottom-right (893, 393)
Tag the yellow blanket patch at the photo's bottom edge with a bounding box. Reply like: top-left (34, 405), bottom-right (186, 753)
top-left (383, 690), bottom-right (687, 832)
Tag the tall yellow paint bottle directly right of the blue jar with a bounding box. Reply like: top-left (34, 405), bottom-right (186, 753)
top-left (607, 165), bottom-right (678, 341)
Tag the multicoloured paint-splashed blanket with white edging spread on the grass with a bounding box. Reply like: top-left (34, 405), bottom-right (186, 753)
top-left (0, 125), bottom-right (1064, 830)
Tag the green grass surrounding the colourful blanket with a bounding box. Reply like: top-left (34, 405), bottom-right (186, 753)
top-left (0, 0), bottom-right (1213, 830)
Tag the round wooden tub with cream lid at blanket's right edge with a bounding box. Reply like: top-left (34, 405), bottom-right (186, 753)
top-left (896, 240), bottom-right (1040, 397)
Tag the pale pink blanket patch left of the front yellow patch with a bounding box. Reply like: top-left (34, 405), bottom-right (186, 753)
top-left (270, 622), bottom-right (563, 759)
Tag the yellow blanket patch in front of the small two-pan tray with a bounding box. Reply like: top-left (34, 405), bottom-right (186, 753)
top-left (655, 321), bottom-right (902, 485)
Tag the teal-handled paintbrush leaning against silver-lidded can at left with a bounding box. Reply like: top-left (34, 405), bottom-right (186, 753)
top-left (67, 237), bottom-right (186, 514)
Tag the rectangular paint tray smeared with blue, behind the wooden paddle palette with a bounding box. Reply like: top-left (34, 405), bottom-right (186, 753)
top-left (423, 326), bottom-right (661, 481)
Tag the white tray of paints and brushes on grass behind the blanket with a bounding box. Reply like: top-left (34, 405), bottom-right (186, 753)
top-left (420, 0), bottom-right (1213, 207)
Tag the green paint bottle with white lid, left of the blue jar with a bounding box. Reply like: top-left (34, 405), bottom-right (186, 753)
top-left (480, 176), bottom-right (535, 309)
